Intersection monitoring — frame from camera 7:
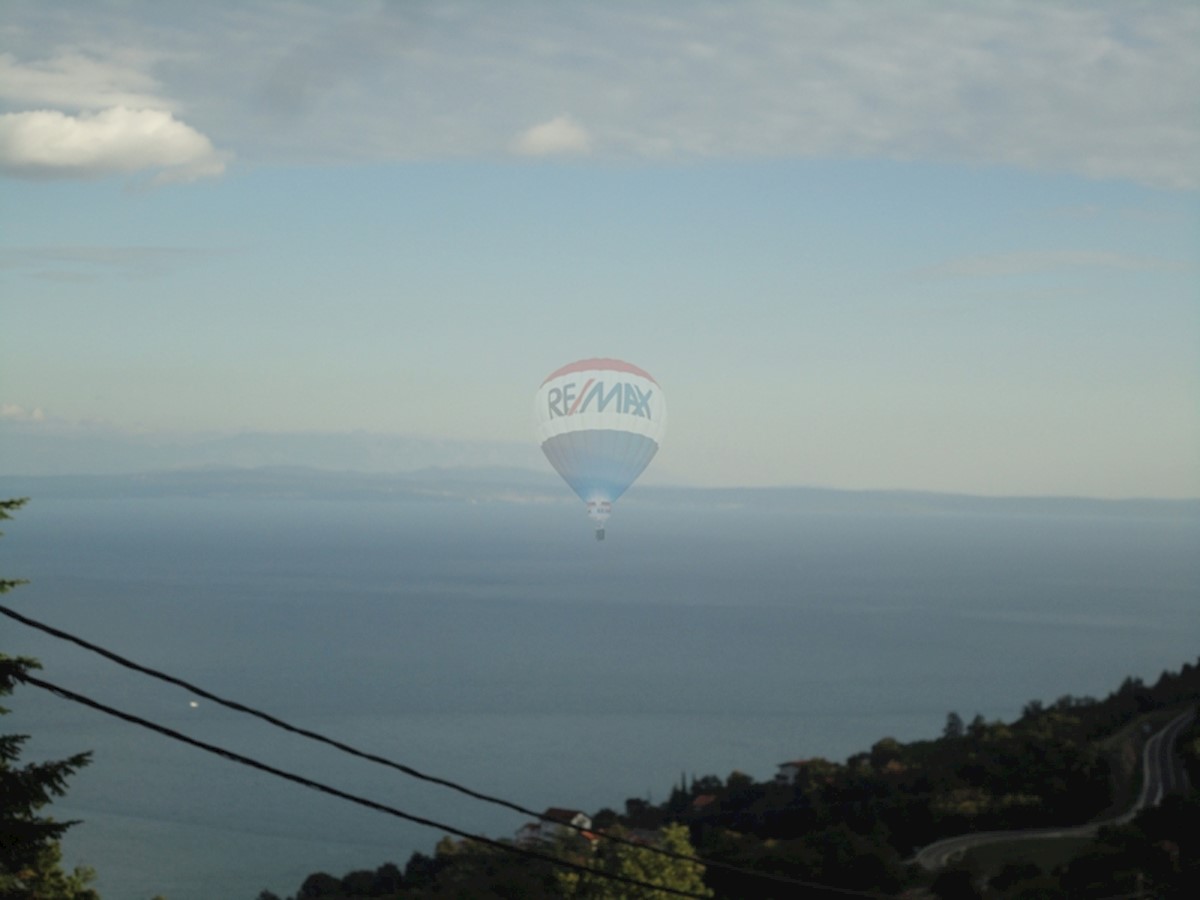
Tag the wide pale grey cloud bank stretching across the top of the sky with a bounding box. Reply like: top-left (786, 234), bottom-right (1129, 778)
top-left (0, 0), bottom-right (1200, 190)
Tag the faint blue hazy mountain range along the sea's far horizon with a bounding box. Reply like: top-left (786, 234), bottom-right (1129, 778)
top-left (0, 466), bottom-right (1200, 520)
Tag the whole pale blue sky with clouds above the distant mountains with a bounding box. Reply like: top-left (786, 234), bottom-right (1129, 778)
top-left (0, 0), bottom-right (1200, 498)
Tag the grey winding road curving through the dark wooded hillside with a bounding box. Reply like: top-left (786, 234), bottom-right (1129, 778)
top-left (911, 709), bottom-right (1195, 870)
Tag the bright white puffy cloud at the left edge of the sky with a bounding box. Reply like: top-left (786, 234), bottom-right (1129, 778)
top-left (0, 107), bottom-right (227, 182)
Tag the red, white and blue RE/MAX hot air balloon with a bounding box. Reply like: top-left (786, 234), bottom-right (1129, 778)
top-left (534, 359), bottom-right (667, 540)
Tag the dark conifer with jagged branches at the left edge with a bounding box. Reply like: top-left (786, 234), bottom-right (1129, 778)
top-left (0, 500), bottom-right (98, 900)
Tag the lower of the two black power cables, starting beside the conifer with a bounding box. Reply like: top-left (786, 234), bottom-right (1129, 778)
top-left (17, 673), bottom-right (707, 898)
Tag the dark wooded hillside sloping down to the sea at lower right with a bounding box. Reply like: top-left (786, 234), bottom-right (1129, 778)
top-left (259, 664), bottom-right (1200, 900)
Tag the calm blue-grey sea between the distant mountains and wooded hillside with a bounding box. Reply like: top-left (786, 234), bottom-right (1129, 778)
top-left (0, 492), bottom-right (1200, 900)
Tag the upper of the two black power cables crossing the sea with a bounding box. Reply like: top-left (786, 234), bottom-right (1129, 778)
top-left (0, 605), bottom-right (890, 900)
